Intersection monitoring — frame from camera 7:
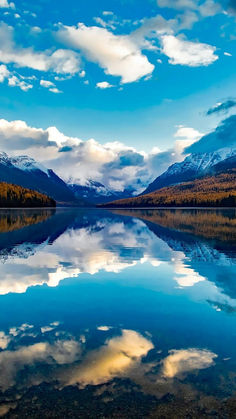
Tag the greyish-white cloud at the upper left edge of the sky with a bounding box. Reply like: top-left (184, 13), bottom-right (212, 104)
top-left (0, 23), bottom-right (80, 74)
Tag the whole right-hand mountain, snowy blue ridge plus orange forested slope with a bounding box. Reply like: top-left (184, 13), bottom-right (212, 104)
top-left (98, 148), bottom-right (236, 208)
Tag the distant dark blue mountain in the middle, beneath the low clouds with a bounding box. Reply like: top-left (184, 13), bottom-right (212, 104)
top-left (68, 180), bottom-right (134, 204)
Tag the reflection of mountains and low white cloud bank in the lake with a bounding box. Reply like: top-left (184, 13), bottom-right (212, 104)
top-left (0, 209), bottom-right (236, 307)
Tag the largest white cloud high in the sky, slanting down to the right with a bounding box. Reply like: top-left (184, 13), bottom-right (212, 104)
top-left (58, 23), bottom-right (154, 83)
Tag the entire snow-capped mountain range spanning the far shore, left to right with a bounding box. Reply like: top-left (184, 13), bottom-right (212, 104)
top-left (0, 147), bottom-right (236, 207)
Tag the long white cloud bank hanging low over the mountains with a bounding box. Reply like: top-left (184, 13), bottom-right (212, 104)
top-left (0, 118), bottom-right (199, 193)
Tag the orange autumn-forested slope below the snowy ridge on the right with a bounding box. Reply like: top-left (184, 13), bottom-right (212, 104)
top-left (99, 169), bottom-right (236, 208)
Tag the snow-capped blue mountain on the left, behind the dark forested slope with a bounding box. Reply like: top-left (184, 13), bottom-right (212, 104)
top-left (0, 152), bottom-right (85, 206)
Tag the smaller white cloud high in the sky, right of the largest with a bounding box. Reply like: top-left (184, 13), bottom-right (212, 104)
top-left (161, 35), bottom-right (218, 67)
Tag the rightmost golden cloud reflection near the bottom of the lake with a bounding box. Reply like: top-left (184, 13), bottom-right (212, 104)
top-left (162, 348), bottom-right (217, 378)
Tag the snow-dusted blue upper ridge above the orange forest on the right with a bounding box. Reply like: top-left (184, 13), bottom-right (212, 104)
top-left (141, 148), bottom-right (236, 195)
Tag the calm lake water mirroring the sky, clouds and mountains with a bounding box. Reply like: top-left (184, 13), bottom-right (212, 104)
top-left (0, 209), bottom-right (236, 419)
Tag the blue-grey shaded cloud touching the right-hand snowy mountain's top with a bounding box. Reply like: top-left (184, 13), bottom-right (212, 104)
top-left (185, 115), bottom-right (236, 153)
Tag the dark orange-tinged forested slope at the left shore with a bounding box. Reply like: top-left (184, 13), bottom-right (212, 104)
top-left (0, 182), bottom-right (56, 208)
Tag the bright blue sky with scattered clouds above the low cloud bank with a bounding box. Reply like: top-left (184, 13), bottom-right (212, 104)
top-left (0, 0), bottom-right (236, 190)
